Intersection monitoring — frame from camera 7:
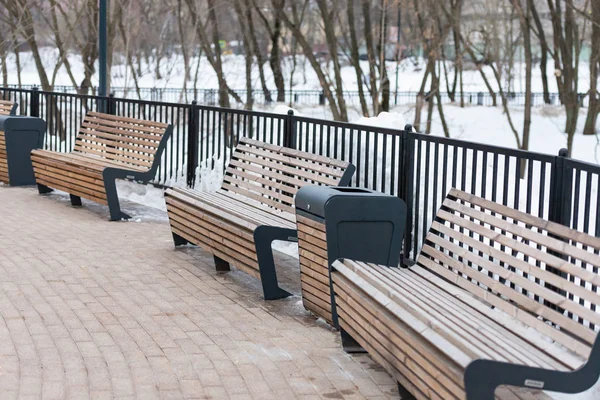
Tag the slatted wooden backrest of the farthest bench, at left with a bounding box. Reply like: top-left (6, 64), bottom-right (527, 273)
top-left (74, 112), bottom-right (173, 170)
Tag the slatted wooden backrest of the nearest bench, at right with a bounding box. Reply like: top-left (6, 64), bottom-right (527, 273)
top-left (417, 189), bottom-right (600, 357)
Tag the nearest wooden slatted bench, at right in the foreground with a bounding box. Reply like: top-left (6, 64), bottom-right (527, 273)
top-left (332, 189), bottom-right (600, 400)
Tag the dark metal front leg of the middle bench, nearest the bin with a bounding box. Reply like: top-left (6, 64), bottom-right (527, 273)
top-left (254, 225), bottom-right (298, 300)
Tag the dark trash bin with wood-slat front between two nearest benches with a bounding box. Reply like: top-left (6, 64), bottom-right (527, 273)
top-left (296, 186), bottom-right (406, 325)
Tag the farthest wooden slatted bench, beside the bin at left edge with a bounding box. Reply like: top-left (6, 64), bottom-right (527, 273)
top-left (31, 112), bottom-right (173, 221)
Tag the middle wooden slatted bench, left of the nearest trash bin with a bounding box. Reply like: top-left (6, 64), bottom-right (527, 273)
top-left (165, 138), bottom-right (355, 300)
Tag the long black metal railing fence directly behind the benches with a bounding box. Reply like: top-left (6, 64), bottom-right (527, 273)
top-left (0, 88), bottom-right (600, 259)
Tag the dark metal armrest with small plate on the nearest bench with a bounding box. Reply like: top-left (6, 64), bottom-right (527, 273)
top-left (464, 335), bottom-right (600, 400)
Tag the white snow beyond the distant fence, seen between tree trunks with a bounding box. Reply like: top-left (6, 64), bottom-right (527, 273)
top-left (0, 47), bottom-right (589, 92)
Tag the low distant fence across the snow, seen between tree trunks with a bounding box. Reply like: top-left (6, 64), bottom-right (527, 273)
top-left (0, 85), bottom-right (588, 107)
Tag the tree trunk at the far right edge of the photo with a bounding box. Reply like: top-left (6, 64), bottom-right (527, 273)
top-left (583, 1), bottom-right (600, 135)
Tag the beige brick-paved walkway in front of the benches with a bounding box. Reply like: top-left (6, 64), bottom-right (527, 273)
top-left (0, 187), bottom-right (397, 400)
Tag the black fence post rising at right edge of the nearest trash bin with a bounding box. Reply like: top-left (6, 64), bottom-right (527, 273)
top-left (398, 124), bottom-right (416, 266)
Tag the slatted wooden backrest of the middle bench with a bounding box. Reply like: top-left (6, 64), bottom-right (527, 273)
top-left (222, 138), bottom-right (355, 212)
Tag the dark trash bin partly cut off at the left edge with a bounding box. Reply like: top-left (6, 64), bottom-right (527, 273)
top-left (0, 115), bottom-right (46, 186)
